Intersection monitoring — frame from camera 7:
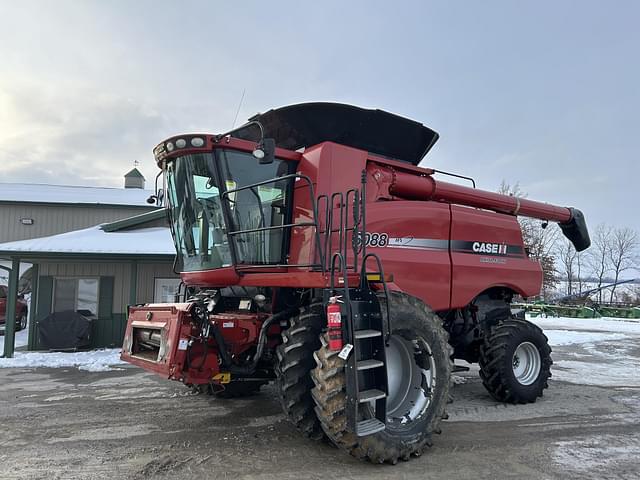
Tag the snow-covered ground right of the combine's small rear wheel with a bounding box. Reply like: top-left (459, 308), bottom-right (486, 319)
top-left (530, 317), bottom-right (640, 387)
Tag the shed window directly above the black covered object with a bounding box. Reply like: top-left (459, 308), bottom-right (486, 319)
top-left (53, 278), bottom-right (99, 315)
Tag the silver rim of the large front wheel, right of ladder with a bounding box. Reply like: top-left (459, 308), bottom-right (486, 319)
top-left (386, 334), bottom-right (436, 426)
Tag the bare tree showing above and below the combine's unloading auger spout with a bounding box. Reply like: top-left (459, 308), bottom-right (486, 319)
top-left (498, 180), bottom-right (560, 298)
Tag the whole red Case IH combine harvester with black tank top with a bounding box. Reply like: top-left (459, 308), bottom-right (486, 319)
top-left (122, 103), bottom-right (590, 463)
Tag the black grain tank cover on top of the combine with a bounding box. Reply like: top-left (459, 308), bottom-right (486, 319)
top-left (233, 102), bottom-right (439, 165)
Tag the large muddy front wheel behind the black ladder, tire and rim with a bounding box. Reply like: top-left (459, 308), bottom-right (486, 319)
top-left (312, 292), bottom-right (451, 464)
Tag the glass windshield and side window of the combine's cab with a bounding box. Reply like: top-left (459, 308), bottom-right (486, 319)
top-left (167, 150), bottom-right (292, 271)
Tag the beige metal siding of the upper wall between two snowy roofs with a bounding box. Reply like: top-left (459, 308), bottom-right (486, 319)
top-left (0, 203), bottom-right (155, 243)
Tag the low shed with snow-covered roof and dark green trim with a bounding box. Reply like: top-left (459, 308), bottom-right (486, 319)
top-left (0, 210), bottom-right (180, 350)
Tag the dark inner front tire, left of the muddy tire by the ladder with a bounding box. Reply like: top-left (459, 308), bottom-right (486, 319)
top-left (275, 300), bottom-right (325, 440)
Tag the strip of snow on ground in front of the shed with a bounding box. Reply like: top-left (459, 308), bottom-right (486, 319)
top-left (0, 348), bottom-right (124, 372)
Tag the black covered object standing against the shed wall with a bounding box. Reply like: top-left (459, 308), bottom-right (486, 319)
top-left (38, 310), bottom-right (91, 350)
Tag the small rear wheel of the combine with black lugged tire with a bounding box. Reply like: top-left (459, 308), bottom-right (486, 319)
top-left (479, 318), bottom-right (553, 403)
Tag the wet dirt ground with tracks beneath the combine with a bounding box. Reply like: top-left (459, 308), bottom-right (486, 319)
top-left (0, 356), bottom-right (640, 480)
